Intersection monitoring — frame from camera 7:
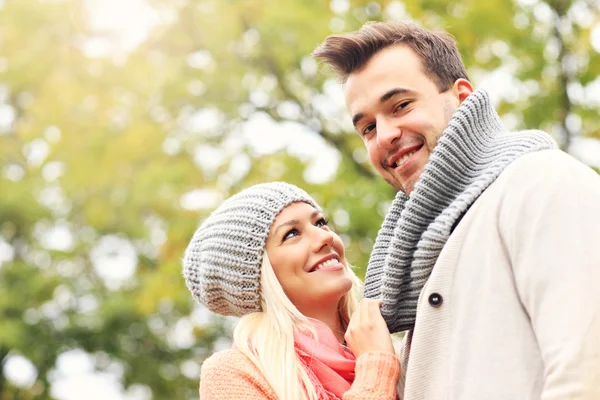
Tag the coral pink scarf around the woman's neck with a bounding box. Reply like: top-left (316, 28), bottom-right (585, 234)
top-left (294, 320), bottom-right (356, 399)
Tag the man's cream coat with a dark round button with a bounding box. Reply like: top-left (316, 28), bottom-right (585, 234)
top-left (402, 150), bottom-right (600, 400)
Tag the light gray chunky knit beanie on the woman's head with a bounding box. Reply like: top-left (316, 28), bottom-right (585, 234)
top-left (183, 182), bottom-right (320, 317)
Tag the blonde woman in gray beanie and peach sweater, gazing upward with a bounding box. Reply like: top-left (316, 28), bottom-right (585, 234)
top-left (183, 182), bottom-right (400, 400)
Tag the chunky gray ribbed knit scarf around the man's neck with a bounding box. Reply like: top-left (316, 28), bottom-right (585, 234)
top-left (365, 89), bottom-right (556, 333)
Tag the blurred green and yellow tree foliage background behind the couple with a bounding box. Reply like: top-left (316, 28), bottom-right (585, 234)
top-left (0, 0), bottom-right (600, 400)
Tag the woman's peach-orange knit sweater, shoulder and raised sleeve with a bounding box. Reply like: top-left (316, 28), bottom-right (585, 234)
top-left (200, 349), bottom-right (400, 400)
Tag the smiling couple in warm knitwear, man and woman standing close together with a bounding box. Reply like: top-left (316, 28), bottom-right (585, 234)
top-left (183, 23), bottom-right (600, 400)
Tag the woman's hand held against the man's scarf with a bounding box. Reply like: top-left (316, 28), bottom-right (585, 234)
top-left (344, 299), bottom-right (395, 358)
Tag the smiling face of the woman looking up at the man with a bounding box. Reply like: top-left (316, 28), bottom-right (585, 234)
top-left (266, 203), bottom-right (352, 317)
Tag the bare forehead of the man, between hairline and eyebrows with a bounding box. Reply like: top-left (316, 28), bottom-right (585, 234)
top-left (344, 44), bottom-right (435, 114)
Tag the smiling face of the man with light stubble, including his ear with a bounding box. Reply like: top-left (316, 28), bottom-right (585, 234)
top-left (344, 44), bottom-right (473, 194)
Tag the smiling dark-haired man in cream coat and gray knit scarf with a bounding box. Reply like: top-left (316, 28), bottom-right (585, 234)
top-left (314, 23), bottom-right (600, 400)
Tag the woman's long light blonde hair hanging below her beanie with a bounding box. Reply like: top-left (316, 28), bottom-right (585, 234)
top-left (233, 252), bottom-right (362, 400)
